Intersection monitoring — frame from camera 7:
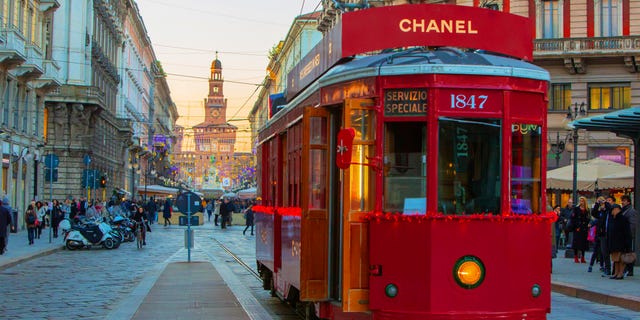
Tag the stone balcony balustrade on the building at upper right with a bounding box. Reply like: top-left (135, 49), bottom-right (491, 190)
top-left (533, 36), bottom-right (640, 59)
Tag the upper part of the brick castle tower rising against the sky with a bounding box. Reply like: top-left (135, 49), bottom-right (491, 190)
top-left (204, 52), bottom-right (227, 124)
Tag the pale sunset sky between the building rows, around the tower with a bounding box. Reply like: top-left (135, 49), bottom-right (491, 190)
top-left (136, 0), bottom-right (322, 152)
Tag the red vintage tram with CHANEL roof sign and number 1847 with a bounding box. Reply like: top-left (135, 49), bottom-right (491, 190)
top-left (254, 4), bottom-right (553, 319)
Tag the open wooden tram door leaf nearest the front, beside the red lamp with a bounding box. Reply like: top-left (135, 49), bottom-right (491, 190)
top-left (342, 99), bottom-right (376, 312)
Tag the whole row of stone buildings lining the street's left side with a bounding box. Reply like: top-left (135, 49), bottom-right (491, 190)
top-left (0, 0), bottom-right (178, 227)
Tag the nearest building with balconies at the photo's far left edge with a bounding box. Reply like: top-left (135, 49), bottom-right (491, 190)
top-left (0, 0), bottom-right (60, 221)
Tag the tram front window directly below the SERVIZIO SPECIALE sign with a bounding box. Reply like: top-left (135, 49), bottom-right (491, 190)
top-left (384, 122), bottom-right (427, 214)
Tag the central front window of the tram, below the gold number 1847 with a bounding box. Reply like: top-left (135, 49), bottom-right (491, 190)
top-left (438, 117), bottom-right (502, 214)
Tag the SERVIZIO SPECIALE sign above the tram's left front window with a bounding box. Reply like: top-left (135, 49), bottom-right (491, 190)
top-left (384, 88), bottom-right (427, 117)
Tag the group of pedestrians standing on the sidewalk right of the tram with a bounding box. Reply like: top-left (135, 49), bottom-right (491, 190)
top-left (553, 195), bottom-right (637, 280)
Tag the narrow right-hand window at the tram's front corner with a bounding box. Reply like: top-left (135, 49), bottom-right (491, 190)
top-left (511, 123), bottom-right (542, 214)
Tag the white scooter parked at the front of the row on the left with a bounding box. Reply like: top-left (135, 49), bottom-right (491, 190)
top-left (59, 219), bottom-right (120, 250)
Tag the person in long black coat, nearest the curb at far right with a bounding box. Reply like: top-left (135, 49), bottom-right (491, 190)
top-left (607, 204), bottom-right (631, 280)
